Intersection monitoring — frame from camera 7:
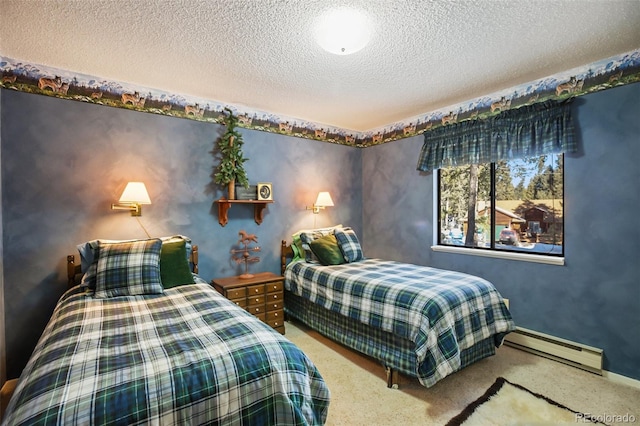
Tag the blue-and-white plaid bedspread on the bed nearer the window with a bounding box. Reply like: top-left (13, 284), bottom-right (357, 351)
top-left (285, 259), bottom-right (515, 387)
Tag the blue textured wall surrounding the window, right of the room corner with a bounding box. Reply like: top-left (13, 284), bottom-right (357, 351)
top-left (363, 84), bottom-right (640, 379)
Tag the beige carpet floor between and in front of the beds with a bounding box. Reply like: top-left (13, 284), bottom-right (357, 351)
top-left (286, 322), bottom-right (640, 425)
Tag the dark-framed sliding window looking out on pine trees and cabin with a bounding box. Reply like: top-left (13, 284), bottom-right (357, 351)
top-left (438, 154), bottom-right (564, 256)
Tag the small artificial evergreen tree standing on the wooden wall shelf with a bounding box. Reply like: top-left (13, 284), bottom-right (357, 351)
top-left (214, 108), bottom-right (249, 200)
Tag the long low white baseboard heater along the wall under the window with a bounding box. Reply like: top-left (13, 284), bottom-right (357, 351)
top-left (504, 327), bottom-right (602, 375)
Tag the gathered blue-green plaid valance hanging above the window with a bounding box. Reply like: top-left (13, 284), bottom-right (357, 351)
top-left (417, 98), bottom-right (577, 172)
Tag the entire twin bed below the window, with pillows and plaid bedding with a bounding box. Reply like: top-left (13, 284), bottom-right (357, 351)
top-left (281, 226), bottom-right (515, 387)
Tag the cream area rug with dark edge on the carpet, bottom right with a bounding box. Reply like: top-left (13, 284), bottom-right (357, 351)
top-left (447, 377), bottom-right (604, 426)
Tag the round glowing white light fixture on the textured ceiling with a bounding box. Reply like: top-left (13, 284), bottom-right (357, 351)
top-left (314, 7), bottom-right (372, 55)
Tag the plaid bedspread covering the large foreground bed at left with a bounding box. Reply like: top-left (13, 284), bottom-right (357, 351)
top-left (3, 284), bottom-right (329, 426)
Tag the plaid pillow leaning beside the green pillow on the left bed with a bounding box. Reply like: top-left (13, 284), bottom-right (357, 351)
top-left (94, 239), bottom-right (163, 299)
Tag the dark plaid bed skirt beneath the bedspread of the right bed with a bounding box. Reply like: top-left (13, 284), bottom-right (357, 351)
top-left (284, 290), bottom-right (496, 386)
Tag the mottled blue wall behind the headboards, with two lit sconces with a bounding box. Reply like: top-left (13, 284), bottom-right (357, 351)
top-left (1, 89), bottom-right (362, 377)
